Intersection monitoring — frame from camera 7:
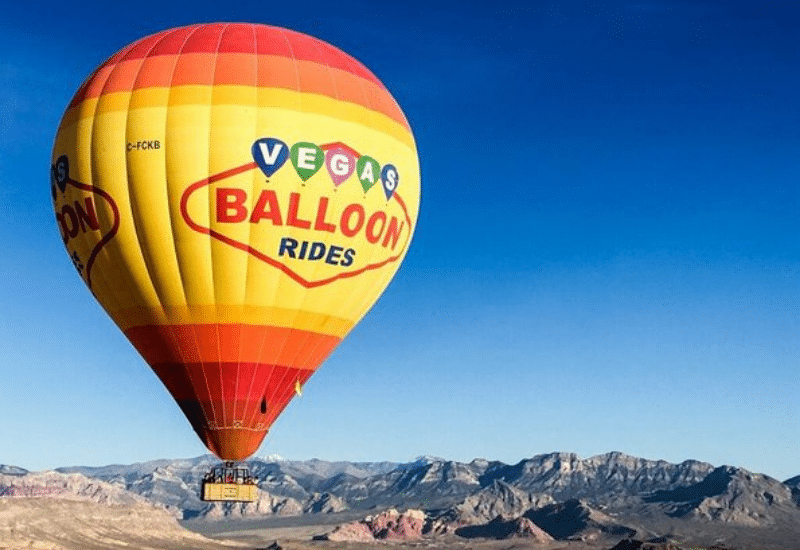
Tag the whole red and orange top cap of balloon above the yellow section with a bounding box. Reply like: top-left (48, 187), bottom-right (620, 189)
top-left (65, 23), bottom-right (409, 129)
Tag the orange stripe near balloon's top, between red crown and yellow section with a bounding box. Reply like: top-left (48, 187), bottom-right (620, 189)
top-left (70, 53), bottom-right (410, 129)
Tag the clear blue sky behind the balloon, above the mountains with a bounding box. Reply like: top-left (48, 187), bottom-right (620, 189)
top-left (0, 0), bottom-right (800, 479)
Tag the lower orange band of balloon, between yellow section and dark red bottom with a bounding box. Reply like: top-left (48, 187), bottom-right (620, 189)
top-left (125, 324), bottom-right (341, 369)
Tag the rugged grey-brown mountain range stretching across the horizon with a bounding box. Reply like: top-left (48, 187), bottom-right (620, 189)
top-left (0, 452), bottom-right (800, 550)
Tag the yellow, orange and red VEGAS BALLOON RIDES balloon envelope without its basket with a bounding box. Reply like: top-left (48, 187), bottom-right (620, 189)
top-left (51, 23), bottom-right (420, 502)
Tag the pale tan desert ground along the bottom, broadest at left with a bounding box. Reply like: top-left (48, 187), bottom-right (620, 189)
top-left (0, 498), bottom-right (780, 550)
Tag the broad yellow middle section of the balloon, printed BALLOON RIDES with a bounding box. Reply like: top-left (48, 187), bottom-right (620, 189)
top-left (56, 96), bottom-right (418, 332)
